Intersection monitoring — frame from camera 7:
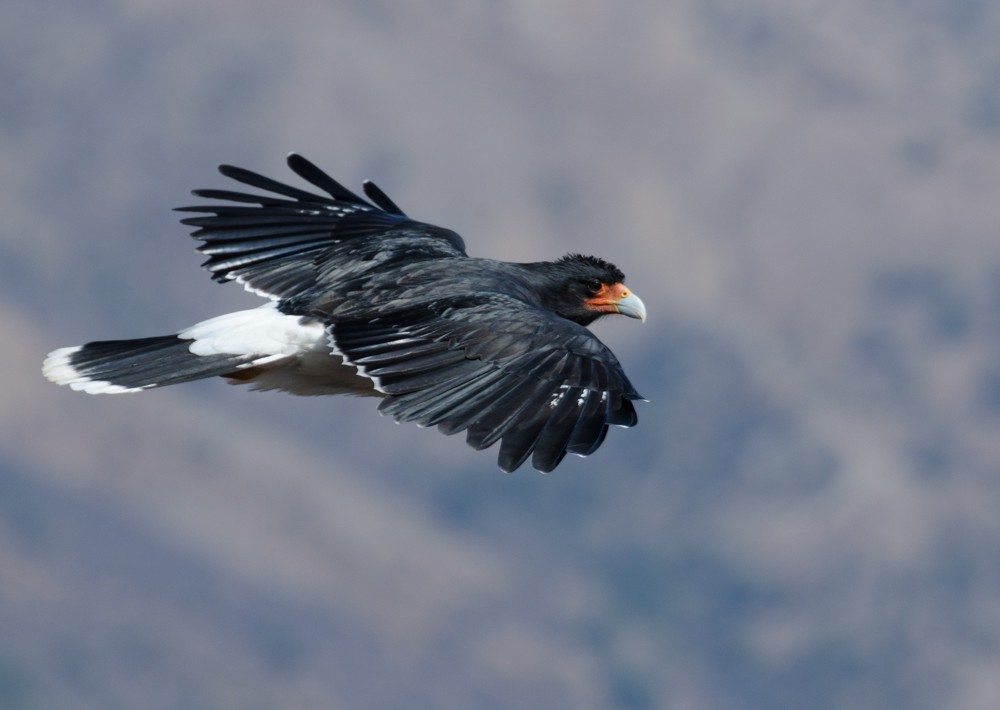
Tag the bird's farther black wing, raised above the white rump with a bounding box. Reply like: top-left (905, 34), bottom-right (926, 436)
top-left (178, 153), bottom-right (465, 299)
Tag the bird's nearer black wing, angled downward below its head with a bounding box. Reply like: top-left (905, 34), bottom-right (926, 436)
top-left (328, 294), bottom-right (640, 472)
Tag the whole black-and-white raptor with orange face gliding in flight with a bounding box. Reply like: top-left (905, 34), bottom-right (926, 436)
top-left (42, 159), bottom-right (646, 472)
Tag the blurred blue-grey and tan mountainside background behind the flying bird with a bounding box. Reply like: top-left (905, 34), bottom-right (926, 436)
top-left (0, 0), bottom-right (1000, 710)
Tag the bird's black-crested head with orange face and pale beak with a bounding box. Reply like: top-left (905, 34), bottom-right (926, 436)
top-left (546, 254), bottom-right (646, 325)
